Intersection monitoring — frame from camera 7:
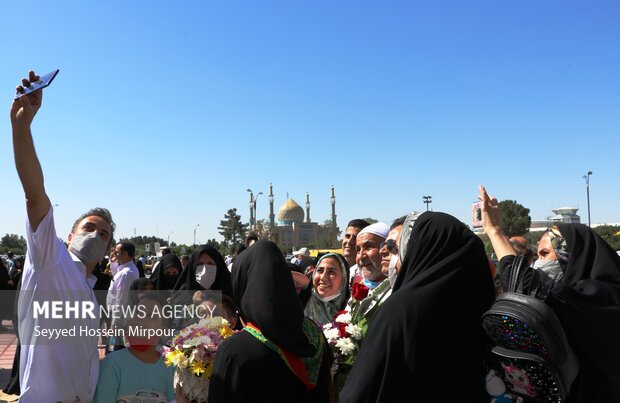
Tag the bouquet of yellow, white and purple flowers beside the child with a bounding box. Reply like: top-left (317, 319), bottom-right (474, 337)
top-left (163, 317), bottom-right (234, 403)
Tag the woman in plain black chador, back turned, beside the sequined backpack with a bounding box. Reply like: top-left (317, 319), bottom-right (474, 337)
top-left (339, 212), bottom-right (495, 403)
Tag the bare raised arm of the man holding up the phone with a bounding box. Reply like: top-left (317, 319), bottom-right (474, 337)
top-left (11, 71), bottom-right (51, 231)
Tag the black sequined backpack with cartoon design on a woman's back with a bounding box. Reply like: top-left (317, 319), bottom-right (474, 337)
top-left (482, 257), bottom-right (579, 402)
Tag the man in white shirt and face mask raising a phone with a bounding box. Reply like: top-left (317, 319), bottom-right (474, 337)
top-left (10, 72), bottom-right (114, 403)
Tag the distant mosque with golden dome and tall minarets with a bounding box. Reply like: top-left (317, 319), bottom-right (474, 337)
top-left (249, 184), bottom-right (340, 250)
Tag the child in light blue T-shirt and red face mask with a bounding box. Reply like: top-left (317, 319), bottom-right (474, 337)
top-left (93, 291), bottom-right (175, 403)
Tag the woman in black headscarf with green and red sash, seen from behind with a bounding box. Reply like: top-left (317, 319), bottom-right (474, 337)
top-left (209, 241), bottom-right (331, 403)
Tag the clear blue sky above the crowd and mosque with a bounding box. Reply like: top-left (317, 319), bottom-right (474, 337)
top-left (0, 0), bottom-right (620, 243)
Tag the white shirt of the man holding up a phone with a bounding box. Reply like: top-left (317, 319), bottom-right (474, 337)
top-left (17, 207), bottom-right (99, 403)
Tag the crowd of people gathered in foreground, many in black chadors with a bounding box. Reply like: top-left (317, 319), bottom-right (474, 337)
top-left (7, 72), bottom-right (620, 403)
